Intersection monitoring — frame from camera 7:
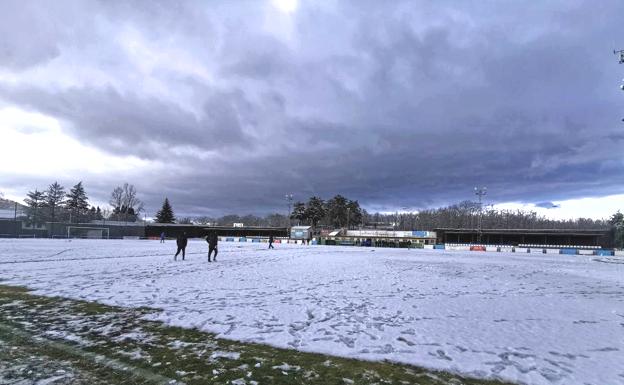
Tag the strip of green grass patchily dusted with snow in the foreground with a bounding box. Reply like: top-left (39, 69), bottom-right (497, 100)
top-left (0, 285), bottom-right (506, 385)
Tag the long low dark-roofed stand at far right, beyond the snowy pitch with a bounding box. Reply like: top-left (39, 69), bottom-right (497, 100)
top-left (435, 228), bottom-right (613, 248)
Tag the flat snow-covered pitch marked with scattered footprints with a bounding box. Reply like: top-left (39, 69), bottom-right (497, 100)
top-left (0, 239), bottom-right (624, 385)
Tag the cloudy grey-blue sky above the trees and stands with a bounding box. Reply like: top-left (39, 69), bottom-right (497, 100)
top-left (0, 0), bottom-right (624, 218)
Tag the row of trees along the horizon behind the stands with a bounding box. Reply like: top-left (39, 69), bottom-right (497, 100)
top-left (18, 182), bottom-right (624, 247)
